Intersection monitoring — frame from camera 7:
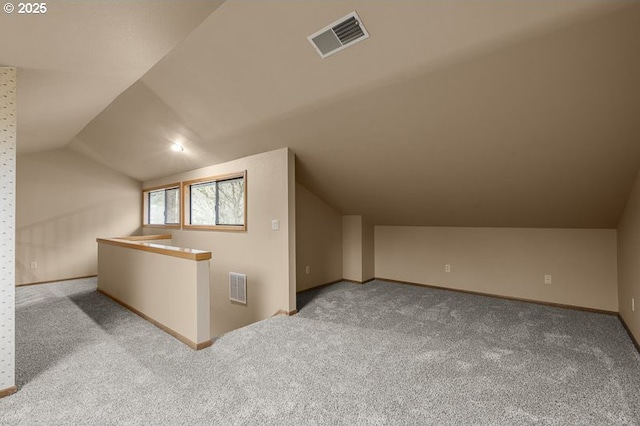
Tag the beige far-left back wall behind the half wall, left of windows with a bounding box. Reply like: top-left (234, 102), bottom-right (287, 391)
top-left (16, 149), bottom-right (142, 285)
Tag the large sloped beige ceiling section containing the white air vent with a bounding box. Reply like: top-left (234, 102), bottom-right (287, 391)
top-left (72, 1), bottom-right (640, 228)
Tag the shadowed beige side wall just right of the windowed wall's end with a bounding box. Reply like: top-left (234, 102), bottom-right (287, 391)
top-left (296, 184), bottom-right (342, 291)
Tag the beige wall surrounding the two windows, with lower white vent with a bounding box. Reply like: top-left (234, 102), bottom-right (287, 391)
top-left (138, 148), bottom-right (296, 337)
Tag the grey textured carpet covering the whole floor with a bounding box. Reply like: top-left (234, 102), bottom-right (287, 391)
top-left (0, 279), bottom-right (640, 425)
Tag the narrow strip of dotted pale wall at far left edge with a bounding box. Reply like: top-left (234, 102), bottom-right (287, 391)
top-left (0, 68), bottom-right (16, 391)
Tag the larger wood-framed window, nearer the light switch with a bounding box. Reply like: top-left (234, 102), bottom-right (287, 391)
top-left (183, 173), bottom-right (246, 231)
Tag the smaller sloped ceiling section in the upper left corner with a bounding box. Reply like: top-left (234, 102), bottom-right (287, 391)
top-left (0, 0), bottom-right (221, 154)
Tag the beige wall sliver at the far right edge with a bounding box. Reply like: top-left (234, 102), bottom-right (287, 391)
top-left (618, 174), bottom-right (640, 341)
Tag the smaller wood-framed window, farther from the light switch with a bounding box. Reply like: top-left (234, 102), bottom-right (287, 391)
top-left (143, 184), bottom-right (180, 226)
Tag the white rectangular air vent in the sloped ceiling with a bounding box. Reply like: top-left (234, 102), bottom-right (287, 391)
top-left (307, 12), bottom-right (369, 58)
